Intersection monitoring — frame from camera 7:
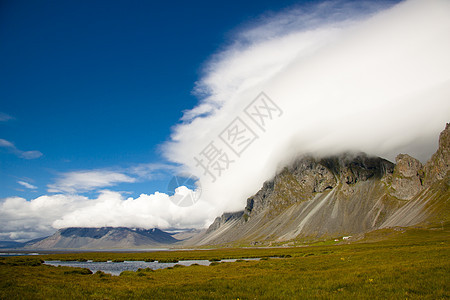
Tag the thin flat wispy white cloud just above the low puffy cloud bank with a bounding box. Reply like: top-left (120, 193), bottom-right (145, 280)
top-left (48, 170), bottom-right (136, 193)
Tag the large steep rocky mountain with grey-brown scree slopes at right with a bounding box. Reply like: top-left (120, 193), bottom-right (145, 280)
top-left (189, 124), bottom-right (450, 245)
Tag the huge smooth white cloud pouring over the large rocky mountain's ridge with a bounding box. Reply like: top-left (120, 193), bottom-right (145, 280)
top-left (165, 0), bottom-right (450, 216)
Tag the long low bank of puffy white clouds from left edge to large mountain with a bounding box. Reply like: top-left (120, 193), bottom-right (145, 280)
top-left (0, 187), bottom-right (218, 241)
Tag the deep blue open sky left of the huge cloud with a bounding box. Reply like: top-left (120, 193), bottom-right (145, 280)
top-left (0, 1), bottom-right (306, 199)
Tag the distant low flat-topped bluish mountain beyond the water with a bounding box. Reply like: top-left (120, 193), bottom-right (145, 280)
top-left (26, 227), bottom-right (179, 249)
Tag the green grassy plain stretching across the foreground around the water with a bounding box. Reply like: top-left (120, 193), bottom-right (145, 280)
top-left (0, 227), bottom-right (450, 299)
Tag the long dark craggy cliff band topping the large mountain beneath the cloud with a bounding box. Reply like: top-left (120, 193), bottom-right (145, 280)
top-left (244, 153), bottom-right (394, 217)
